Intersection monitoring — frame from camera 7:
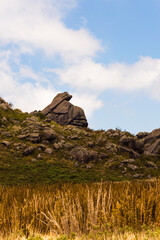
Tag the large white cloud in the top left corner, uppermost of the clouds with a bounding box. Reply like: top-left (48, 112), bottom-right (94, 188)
top-left (0, 0), bottom-right (101, 61)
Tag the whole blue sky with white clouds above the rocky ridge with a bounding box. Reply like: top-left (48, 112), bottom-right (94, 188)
top-left (0, 0), bottom-right (160, 134)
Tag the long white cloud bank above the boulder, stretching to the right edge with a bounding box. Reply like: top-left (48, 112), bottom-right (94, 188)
top-left (53, 57), bottom-right (160, 93)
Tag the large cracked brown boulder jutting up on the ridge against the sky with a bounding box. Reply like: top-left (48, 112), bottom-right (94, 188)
top-left (42, 92), bottom-right (88, 127)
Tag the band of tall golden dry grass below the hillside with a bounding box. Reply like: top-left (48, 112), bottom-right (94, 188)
top-left (0, 179), bottom-right (160, 240)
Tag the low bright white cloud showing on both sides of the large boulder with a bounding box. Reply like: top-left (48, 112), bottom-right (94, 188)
top-left (0, 51), bottom-right (102, 118)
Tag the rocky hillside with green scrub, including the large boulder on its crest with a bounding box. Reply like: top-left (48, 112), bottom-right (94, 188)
top-left (0, 93), bottom-right (160, 184)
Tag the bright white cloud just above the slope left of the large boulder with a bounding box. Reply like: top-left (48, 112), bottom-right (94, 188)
top-left (0, 51), bottom-right (57, 112)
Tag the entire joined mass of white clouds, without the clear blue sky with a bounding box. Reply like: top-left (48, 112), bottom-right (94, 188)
top-left (0, 0), bottom-right (160, 122)
